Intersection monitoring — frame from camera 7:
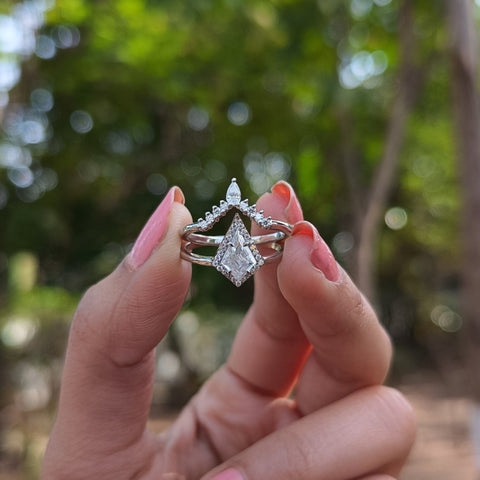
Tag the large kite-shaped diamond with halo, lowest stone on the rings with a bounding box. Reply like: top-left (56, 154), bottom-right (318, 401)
top-left (212, 214), bottom-right (264, 287)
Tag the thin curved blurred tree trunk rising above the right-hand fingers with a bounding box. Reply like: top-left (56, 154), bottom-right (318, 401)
top-left (355, 0), bottom-right (420, 304)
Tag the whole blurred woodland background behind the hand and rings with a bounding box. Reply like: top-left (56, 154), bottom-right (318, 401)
top-left (0, 0), bottom-right (480, 480)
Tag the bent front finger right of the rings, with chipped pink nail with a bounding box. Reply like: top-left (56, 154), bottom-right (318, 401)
top-left (278, 221), bottom-right (392, 414)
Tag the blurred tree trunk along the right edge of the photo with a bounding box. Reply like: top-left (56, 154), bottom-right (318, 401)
top-left (448, 0), bottom-right (480, 470)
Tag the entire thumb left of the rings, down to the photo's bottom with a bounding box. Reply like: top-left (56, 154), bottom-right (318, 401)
top-left (42, 187), bottom-right (191, 478)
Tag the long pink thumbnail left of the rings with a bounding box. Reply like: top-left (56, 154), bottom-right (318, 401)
top-left (129, 187), bottom-right (185, 270)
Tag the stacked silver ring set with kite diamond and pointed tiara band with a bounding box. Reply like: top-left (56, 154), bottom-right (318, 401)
top-left (181, 178), bottom-right (293, 287)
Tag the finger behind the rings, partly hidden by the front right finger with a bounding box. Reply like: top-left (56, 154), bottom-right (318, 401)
top-left (227, 182), bottom-right (309, 396)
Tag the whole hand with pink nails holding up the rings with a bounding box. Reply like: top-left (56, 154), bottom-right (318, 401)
top-left (42, 182), bottom-right (414, 480)
